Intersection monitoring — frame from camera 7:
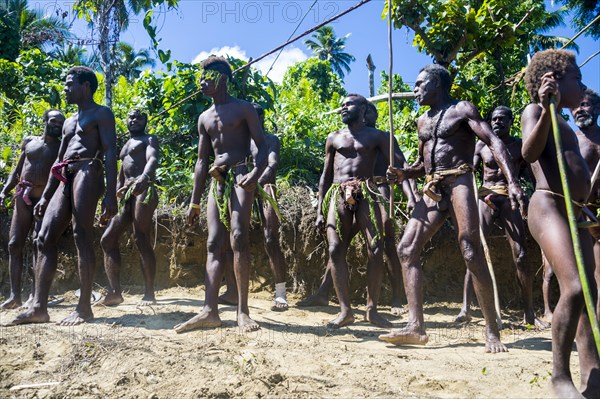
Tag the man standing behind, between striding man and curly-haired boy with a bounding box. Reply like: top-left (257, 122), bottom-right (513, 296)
top-left (456, 106), bottom-right (547, 328)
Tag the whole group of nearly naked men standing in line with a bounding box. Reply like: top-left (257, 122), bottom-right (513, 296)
top-left (3, 50), bottom-right (600, 397)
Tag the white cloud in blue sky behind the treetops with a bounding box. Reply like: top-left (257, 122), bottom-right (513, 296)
top-left (192, 46), bottom-right (308, 83)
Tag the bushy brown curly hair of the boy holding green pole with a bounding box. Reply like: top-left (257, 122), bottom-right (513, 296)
top-left (525, 49), bottom-right (577, 103)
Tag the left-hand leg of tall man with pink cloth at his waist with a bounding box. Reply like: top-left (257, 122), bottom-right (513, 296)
top-left (9, 186), bottom-right (71, 325)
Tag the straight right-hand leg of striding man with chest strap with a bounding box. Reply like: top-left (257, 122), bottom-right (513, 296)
top-left (450, 174), bottom-right (507, 353)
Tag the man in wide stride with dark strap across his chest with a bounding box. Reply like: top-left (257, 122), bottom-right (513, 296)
top-left (379, 64), bottom-right (523, 352)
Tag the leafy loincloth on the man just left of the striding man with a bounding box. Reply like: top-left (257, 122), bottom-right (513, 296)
top-left (321, 179), bottom-right (383, 245)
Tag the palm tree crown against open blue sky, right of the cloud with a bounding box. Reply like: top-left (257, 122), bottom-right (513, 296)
top-left (304, 25), bottom-right (355, 79)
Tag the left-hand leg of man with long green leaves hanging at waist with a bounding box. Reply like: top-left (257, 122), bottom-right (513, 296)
top-left (178, 194), bottom-right (229, 334)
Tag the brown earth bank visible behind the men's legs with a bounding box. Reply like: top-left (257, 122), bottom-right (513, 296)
top-left (0, 187), bottom-right (542, 307)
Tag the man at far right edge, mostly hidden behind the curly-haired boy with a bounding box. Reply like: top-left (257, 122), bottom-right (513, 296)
top-left (542, 89), bottom-right (600, 322)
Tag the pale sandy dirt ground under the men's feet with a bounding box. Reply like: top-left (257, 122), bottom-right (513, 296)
top-left (0, 287), bottom-right (578, 398)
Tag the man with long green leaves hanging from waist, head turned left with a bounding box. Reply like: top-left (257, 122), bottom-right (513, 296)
top-left (175, 56), bottom-right (267, 333)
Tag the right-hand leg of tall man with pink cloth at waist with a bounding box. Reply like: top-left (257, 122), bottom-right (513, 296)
top-left (58, 162), bottom-right (104, 326)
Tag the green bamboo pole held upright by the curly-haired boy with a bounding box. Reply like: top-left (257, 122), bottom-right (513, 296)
top-left (550, 97), bottom-right (600, 356)
